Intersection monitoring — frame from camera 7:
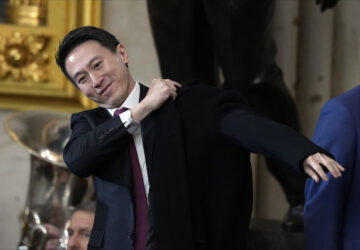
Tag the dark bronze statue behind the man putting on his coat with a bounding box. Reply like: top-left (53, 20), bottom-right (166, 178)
top-left (147, 0), bottom-right (337, 231)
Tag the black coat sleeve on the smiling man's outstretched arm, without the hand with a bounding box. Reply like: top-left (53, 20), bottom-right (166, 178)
top-left (216, 90), bottom-right (329, 173)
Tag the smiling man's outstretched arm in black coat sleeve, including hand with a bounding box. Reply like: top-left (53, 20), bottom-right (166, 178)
top-left (217, 91), bottom-right (344, 181)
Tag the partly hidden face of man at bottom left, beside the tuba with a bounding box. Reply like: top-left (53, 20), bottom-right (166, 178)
top-left (68, 211), bottom-right (94, 250)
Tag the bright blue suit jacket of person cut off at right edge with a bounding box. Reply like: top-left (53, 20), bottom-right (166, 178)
top-left (304, 87), bottom-right (360, 250)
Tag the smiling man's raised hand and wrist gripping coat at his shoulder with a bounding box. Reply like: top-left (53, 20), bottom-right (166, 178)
top-left (131, 78), bottom-right (181, 122)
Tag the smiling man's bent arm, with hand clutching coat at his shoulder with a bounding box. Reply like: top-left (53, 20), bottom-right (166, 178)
top-left (63, 78), bottom-right (181, 177)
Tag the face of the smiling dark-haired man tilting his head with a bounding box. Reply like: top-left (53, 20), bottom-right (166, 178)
top-left (65, 40), bottom-right (135, 108)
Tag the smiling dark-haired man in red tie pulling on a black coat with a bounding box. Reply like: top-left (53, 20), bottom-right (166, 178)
top-left (56, 27), bottom-right (342, 250)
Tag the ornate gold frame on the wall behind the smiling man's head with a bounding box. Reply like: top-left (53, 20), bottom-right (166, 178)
top-left (0, 0), bottom-right (102, 112)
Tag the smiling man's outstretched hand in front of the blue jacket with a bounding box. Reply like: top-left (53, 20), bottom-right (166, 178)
top-left (303, 153), bottom-right (345, 182)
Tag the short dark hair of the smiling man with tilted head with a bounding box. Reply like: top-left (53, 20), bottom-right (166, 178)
top-left (55, 26), bottom-right (120, 88)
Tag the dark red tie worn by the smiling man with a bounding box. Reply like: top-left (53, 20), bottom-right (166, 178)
top-left (114, 108), bottom-right (148, 250)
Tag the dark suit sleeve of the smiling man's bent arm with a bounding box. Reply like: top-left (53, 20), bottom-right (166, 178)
top-left (63, 112), bottom-right (131, 177)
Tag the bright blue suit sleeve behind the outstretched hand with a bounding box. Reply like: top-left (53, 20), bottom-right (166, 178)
top-left (304, 100), bottom-right (356, 250)
